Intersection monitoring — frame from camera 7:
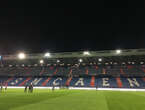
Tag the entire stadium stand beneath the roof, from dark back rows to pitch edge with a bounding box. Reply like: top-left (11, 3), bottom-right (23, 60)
top-left (0, 50), bottom-right (145, 88)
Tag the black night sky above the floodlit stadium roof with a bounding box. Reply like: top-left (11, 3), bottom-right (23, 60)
top-left (0, 1), bottom-right (145, 54)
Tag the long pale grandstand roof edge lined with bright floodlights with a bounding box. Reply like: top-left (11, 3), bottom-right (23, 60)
top-left (2, 49), bottom-right (145, 60)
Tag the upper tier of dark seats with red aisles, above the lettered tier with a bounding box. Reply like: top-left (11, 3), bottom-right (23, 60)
top-left (0, 65), bottom-right (145, 76)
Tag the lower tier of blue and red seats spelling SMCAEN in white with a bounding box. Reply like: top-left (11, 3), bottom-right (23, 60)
top-left (0, 77), bottom-right (145, 88)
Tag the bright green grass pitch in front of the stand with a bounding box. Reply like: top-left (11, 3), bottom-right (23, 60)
top-left (0, 89), bottom-right (145, 110)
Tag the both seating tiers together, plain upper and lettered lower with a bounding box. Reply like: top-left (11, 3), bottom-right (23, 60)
top-left (0, 62), bottom-right (145, 88)
